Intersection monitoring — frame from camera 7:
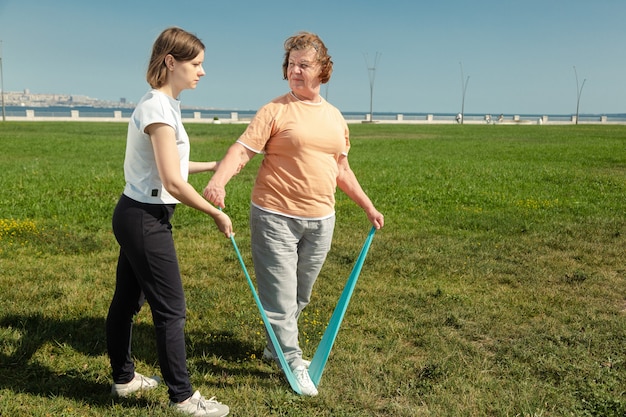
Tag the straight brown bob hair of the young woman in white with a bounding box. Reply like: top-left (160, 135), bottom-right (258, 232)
top-left (146, 27), bottom-right (205, 88)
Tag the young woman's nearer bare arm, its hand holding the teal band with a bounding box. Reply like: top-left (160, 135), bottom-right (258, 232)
top-left (146, 123), bottom-right (233, 237)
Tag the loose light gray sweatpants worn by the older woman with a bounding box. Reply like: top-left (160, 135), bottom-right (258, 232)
top-left (250, 206), bottom-right (335, 369)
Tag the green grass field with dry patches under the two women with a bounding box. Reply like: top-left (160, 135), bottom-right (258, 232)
top-left (0, 122), bottom-right (626, 417)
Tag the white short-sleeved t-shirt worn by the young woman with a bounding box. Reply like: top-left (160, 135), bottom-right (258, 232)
top-left (124, 90), bottom-right (189, 204)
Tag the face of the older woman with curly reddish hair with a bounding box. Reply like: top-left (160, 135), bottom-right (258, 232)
top-left (287, 48), bottom-right (321, 95)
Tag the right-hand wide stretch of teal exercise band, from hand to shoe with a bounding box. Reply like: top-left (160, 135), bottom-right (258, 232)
top-left (309, 227), bottom-right (376, 386)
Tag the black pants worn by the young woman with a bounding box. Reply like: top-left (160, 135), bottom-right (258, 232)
top-left (106, 195), bottom-right (192, 402)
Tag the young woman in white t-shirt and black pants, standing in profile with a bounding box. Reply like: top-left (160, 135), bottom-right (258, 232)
top-left (106, 28), bottom-right (232, 416)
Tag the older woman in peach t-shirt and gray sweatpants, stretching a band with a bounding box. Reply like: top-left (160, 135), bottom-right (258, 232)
top-left (204, 32), bottom-right (384, 396)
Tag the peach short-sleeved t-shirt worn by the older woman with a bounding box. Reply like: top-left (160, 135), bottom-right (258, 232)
top-left (237, 93), bottom-right (350, 219)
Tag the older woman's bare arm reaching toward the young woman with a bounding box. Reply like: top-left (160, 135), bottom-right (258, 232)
top-left (203, 142), bottom-right (256, 208)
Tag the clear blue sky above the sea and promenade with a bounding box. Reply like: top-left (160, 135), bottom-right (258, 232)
top-left (0, 0), bottom-right (626, 114)
